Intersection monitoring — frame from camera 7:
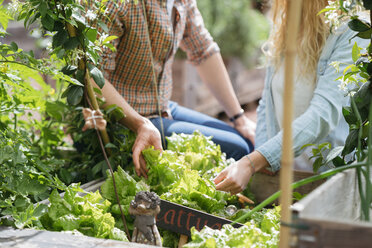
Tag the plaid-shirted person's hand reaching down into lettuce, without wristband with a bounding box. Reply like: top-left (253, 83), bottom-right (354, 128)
top-left (132, 118), bottom-right (163, 178)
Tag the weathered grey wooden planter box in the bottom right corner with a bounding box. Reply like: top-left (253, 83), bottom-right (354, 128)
top-left (292, 169), bottom-right (372, 248)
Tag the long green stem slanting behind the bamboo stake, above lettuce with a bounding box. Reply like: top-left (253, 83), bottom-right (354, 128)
top-left (232, 162), bottom-right (366, 225)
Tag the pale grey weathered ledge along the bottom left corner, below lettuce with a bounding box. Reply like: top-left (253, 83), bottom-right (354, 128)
top-left (0, 226), bottom-right (155, 248)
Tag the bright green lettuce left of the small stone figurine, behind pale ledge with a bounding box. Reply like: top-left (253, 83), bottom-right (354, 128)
top-left (41, 184), bottom-right (128, 241)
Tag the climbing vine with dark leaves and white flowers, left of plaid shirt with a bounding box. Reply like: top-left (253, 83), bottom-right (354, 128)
top-left (11, 0), bottom-right (120, 106)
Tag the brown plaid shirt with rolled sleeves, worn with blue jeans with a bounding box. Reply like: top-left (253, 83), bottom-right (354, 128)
top-left (102, 0), bottom-right (219, 117)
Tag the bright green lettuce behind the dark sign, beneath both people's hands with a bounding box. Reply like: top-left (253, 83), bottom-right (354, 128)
top-left (101, 132), bottom-right (253, 237)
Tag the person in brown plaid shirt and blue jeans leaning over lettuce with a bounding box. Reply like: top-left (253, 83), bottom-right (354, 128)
top-left (93, 0), bottom-right (255, 176)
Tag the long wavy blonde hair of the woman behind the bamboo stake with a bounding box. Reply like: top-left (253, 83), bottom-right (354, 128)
top-left (264, 0), bottom-right (330, 74)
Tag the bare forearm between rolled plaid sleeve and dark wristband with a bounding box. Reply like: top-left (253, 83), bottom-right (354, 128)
top-left (196, 53), bottom-right (241, 117)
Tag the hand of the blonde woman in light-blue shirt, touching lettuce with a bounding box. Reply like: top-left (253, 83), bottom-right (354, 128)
top-left (214, 157), bottom-right (254, 195)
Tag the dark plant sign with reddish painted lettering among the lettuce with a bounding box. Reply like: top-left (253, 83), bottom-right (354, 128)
top-left (156, 200), bottom-right (242, 236)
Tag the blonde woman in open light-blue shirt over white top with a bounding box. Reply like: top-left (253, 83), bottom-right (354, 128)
top-left (215, 0), bottom-right (368, 194)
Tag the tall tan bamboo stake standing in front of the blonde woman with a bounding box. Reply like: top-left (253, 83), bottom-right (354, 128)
top-left (279, 0), bottom-right (302, 248)
